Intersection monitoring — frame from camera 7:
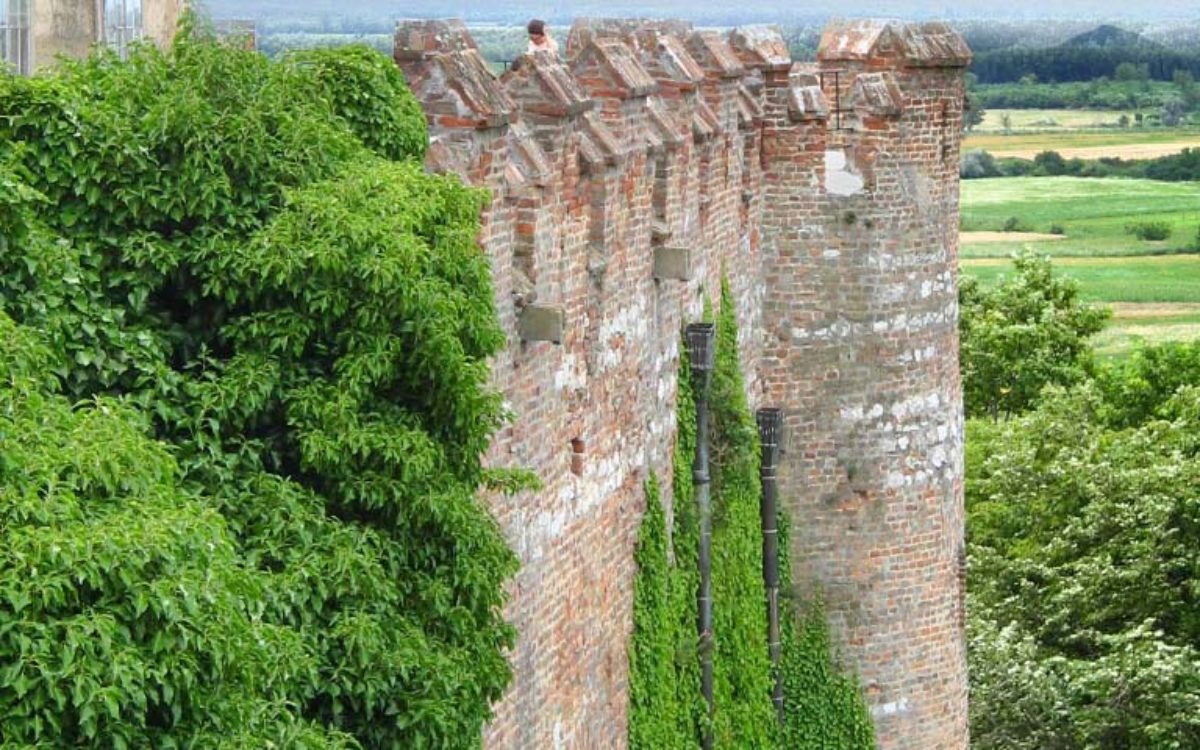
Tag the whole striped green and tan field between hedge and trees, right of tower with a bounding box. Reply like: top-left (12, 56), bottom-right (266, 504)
top-left (960, 178), bottom-right (1200, 356)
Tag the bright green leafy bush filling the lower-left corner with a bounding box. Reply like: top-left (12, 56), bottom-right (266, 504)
top-left (0, 312), bottom-right (358, 749)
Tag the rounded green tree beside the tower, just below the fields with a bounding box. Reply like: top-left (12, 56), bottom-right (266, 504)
top-left (959, 254), bottom-right (1109, 419)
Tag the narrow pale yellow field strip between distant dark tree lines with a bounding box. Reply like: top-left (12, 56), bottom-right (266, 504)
top-left (962, 129), bottom-right (1200, 158)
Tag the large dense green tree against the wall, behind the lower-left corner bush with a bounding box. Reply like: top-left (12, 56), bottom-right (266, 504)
top-left (0, 22), bottom-right (528, 748)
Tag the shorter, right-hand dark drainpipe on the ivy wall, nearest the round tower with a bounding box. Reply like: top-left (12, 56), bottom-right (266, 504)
top-left (755, 409), bottom-right (784, 722)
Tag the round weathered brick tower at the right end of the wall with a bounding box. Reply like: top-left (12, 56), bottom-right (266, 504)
top-left (748, 22), bottom-right (970, 750)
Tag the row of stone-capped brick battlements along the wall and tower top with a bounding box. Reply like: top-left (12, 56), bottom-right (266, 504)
top-left (395, 18), bottom-right (971, 198)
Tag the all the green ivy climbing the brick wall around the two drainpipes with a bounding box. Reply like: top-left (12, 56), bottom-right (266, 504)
top-left (629, 283), bottom-right (875, 750)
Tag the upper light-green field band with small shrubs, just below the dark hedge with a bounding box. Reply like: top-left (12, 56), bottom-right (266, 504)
top-left (960, 178), bottom-right (1200, 258)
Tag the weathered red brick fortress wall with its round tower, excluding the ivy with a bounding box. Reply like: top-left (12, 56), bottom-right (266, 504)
top-left (396, 20), bottom-right (970, 750)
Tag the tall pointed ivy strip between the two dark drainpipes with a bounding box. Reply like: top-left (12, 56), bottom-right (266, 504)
top-left (709, 281), bottom-right (775, 750)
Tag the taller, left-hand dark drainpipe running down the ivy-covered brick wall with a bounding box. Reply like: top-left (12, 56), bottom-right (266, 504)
top-left (686, 323), bottom-right (716, 750)
